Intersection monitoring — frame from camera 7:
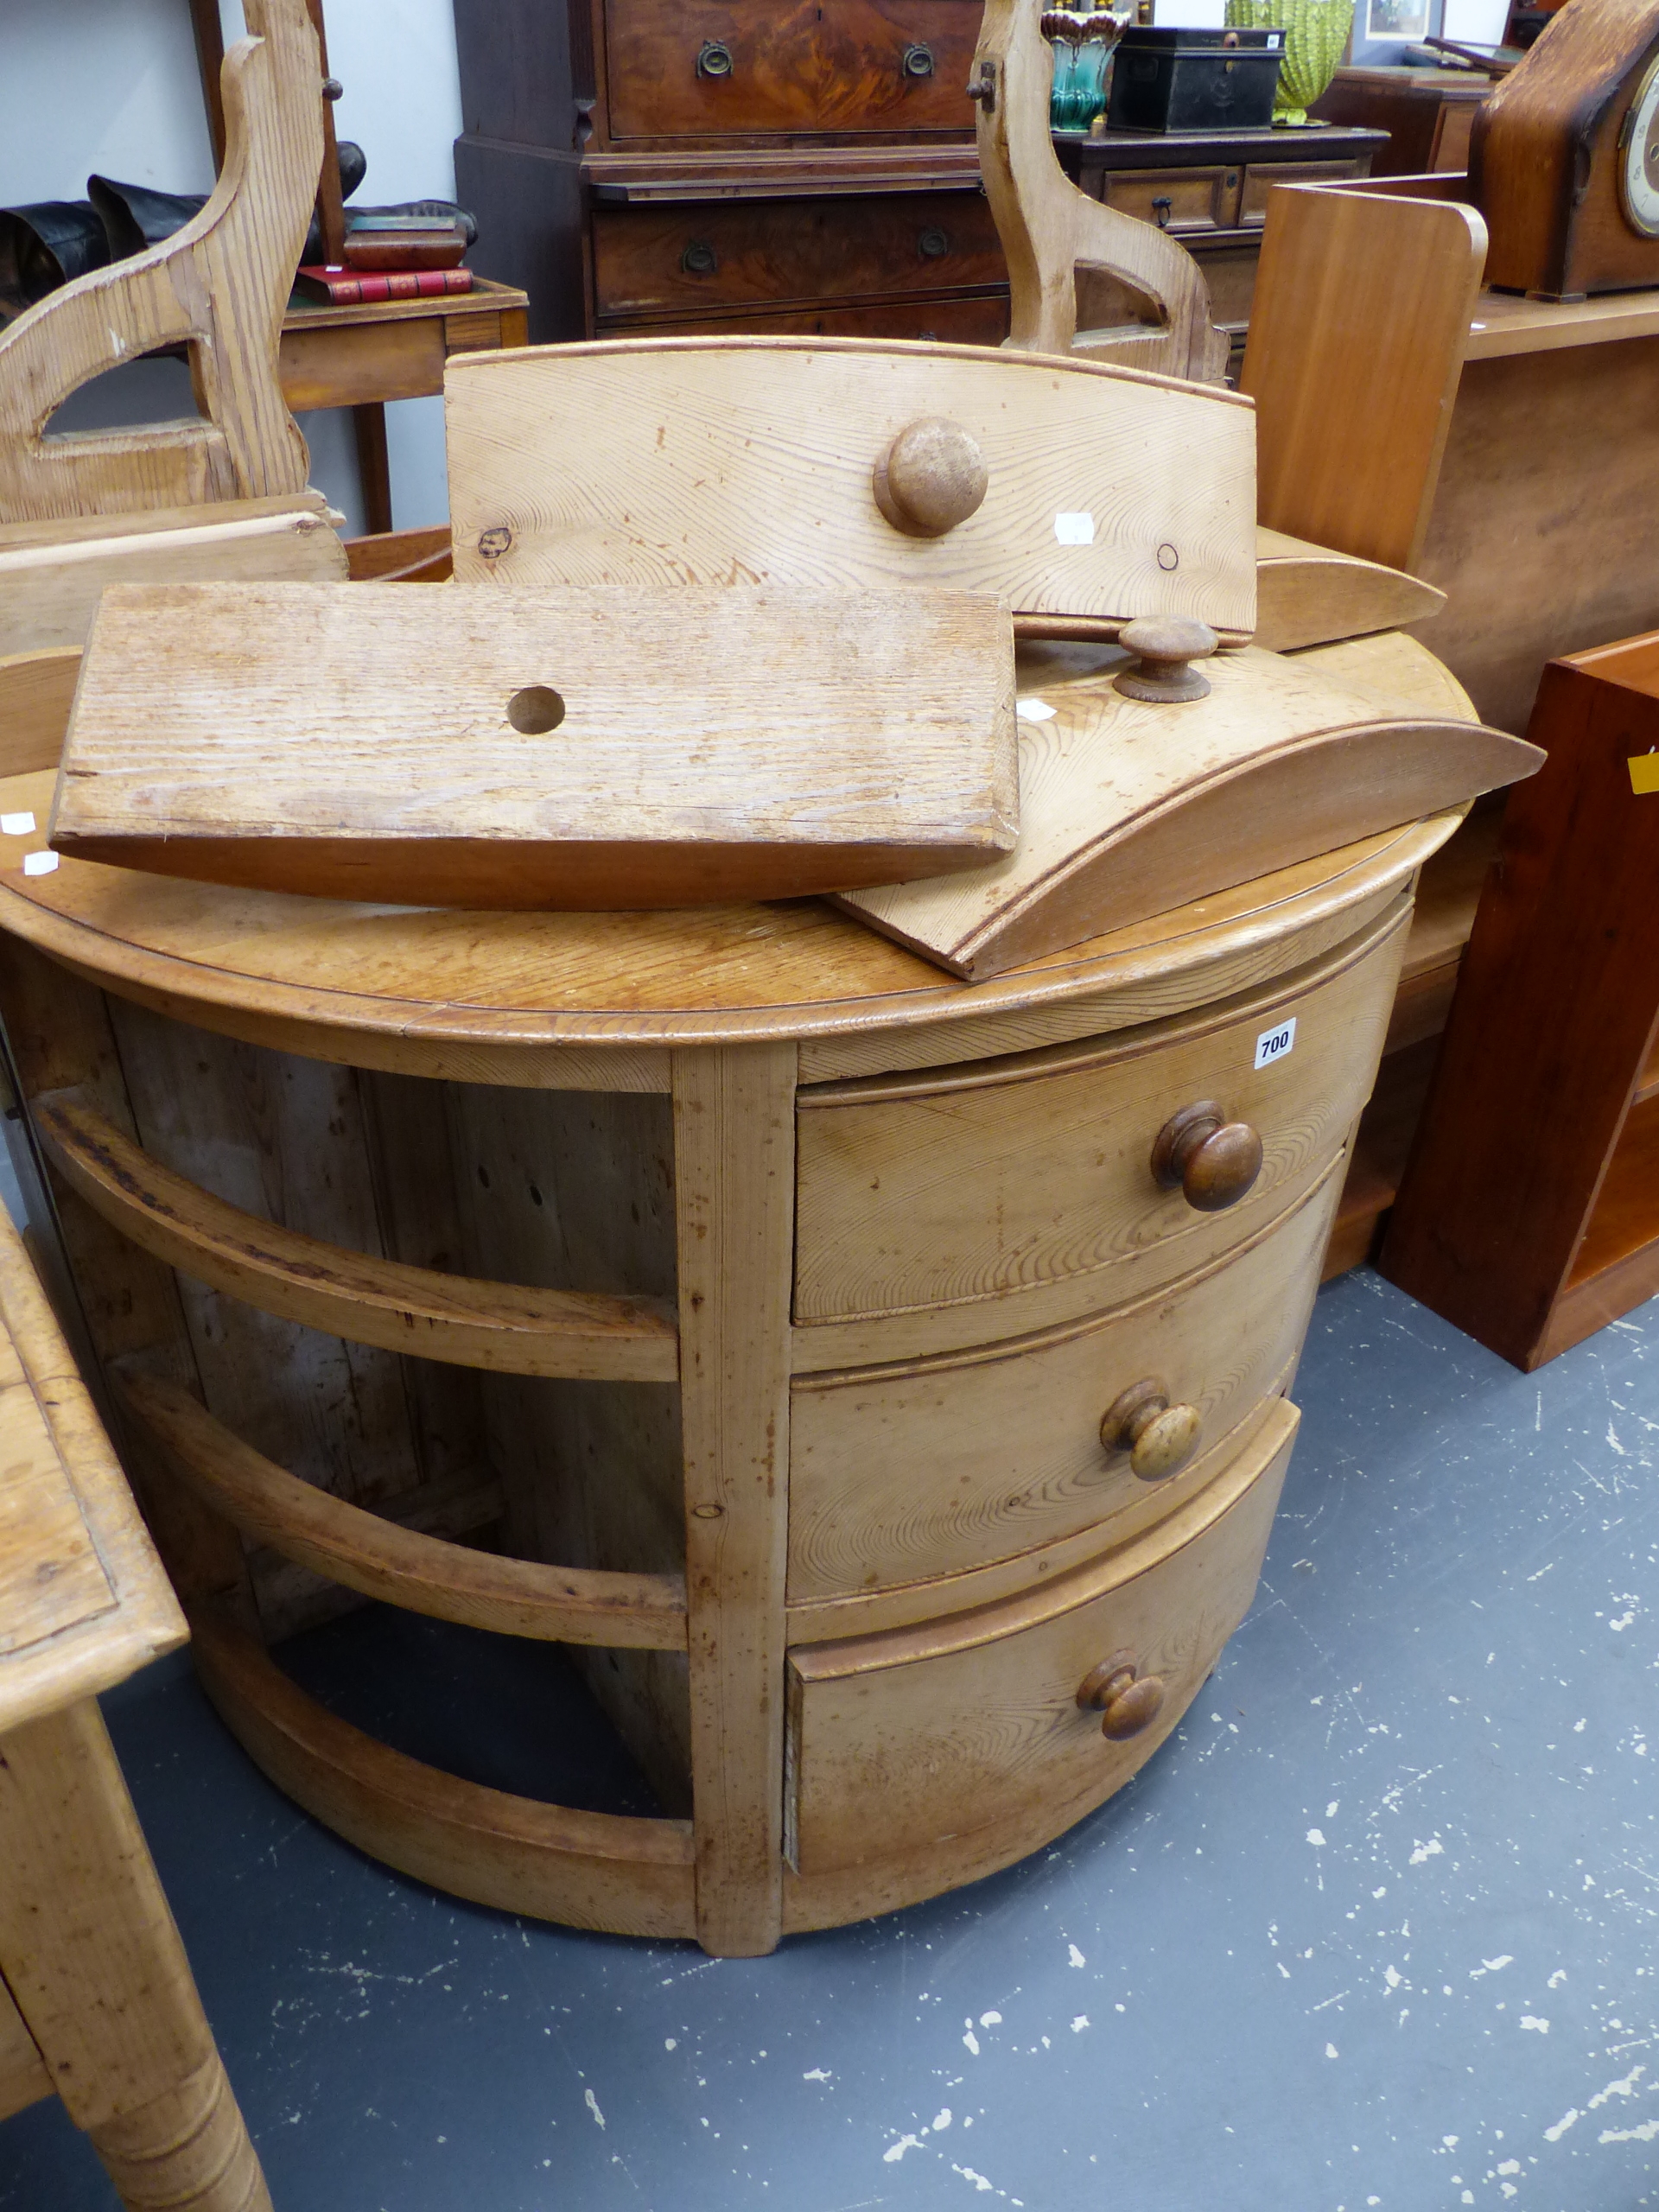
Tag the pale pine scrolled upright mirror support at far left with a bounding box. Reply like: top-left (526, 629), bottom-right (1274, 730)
top-left (0, 0), bottom-right (345, 652)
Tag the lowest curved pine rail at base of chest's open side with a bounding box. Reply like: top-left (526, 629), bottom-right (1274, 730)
top-left (190, 1608), bottom-right (696, 1938)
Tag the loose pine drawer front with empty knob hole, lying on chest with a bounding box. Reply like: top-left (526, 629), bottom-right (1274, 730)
top-left (51, 584), bottom-right (1020, 909)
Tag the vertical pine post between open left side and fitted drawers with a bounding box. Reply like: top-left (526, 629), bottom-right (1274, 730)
top-left (675, 1044), bottom-right (797, 1958)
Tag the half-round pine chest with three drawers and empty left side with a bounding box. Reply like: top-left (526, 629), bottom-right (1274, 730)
top-left (0, 716), bottom-right (1455, 1953)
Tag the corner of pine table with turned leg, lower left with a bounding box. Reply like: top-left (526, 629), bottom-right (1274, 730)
top-left (0, 1214), bottom-right (270, 2212)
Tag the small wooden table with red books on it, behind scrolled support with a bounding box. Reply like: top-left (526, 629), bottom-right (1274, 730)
top-left (276, 276), bottom-right (529, 533)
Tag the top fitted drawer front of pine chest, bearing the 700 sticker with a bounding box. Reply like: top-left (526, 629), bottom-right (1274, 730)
top-left (794, 902), bottom-right (1409, 1336)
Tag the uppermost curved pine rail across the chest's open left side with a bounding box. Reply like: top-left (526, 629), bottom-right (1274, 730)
top-left (35, 1099), bottom-right (679, 1382)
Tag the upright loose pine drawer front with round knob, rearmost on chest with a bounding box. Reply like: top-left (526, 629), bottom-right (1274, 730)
top-left (445, 336), bottom-right (1256, 641)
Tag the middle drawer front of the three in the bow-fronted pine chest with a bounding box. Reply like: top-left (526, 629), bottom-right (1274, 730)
top-left (790, 1159), bottom-right (1343, 1635)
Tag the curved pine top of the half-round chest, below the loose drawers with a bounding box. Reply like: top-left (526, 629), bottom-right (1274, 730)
top-left (0, 772), bottom-right (1462, 1071)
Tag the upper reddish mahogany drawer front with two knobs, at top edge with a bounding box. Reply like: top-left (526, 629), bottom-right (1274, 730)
top-left (604, 0), bottom-right (980, 139)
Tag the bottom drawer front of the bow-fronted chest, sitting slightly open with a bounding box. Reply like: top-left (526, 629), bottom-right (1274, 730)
top-left (787, 1405), bottom-right (1296, 1878)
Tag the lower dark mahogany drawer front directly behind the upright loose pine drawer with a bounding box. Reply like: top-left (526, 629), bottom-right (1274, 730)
top-left (593, 193), bottom-right (1008, 316)
